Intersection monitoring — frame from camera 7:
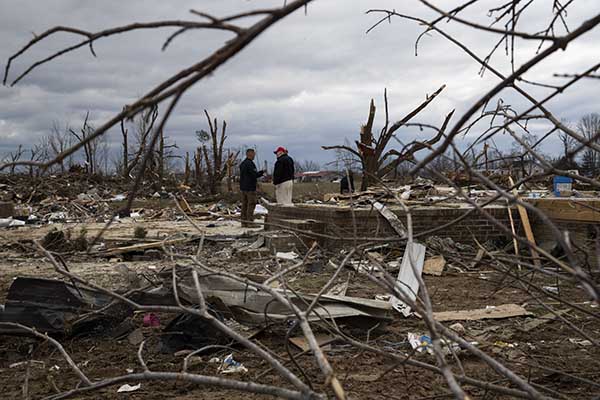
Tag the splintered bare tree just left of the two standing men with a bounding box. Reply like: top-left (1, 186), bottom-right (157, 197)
top-left (194, 110), bottom-right (239, 194)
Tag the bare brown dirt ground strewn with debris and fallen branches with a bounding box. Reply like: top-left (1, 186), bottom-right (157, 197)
top-left (0, 219), bottom-right (600, 400)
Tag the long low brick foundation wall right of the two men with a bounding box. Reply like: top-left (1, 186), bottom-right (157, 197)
top-left (267, 205), bottom-right (520, 247)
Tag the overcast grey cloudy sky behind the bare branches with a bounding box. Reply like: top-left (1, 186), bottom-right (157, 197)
top-left (0, 0), bottom-right (600, 169)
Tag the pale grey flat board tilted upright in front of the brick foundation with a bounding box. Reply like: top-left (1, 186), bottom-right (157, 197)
top-left (390, 242), bottom-right (425, 317)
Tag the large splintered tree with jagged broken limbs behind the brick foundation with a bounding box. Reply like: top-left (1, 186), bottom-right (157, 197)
top-left (323, 85), bottom-right (454, 190)
